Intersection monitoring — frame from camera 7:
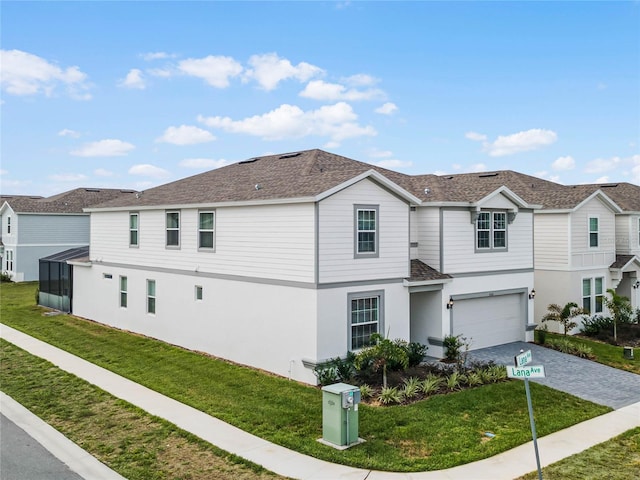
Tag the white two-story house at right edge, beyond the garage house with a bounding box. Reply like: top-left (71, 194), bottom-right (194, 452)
top-left (440, 171), bottom-right (640, 331)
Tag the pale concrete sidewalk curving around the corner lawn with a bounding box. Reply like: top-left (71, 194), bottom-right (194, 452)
top-left (0, 325), bottom-right (640, 480)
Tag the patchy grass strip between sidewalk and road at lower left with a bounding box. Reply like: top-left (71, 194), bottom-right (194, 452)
top-left (0, 340), bottom-right (281, 480)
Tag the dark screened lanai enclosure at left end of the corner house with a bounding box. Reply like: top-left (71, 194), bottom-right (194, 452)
top-left (38, 247), bottom-right (89, 313)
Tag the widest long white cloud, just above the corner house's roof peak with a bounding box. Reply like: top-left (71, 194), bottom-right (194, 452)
top-left (198, 102), bottom-right (377, 146)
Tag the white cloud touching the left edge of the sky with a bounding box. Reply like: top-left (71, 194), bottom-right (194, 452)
top-left (0, 50), bottom-right (91, 100)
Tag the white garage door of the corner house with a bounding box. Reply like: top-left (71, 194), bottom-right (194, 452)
top-left (453, 294), bottom-right (525, 350)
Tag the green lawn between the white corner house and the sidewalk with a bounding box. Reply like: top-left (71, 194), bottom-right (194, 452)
top-left (0, 284), bottom-right (610, 472)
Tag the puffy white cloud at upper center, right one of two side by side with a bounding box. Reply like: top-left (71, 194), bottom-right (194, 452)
top-left (245, 53), bottom-right (324, 90)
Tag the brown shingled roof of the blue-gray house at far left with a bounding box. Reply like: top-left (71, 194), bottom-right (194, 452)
top-left (2, 188), bottom-right (135, 213)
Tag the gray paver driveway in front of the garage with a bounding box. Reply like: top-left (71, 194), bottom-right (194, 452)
top-left (468, 342), bottom-right (640, 409)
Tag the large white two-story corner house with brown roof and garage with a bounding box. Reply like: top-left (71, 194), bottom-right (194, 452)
top-left (69, 150), bottom-right (539, 383)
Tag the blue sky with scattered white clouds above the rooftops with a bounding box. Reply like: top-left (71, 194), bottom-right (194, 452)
top-left (0, 1), bottom-right (640, 196)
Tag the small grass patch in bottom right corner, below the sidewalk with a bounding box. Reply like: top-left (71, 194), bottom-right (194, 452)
top-left (517, 428), bottom-right (640, 480)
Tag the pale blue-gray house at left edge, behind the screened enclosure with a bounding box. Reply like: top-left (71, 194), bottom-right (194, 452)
top-left (0, 188), bottom-right (133, 282)
